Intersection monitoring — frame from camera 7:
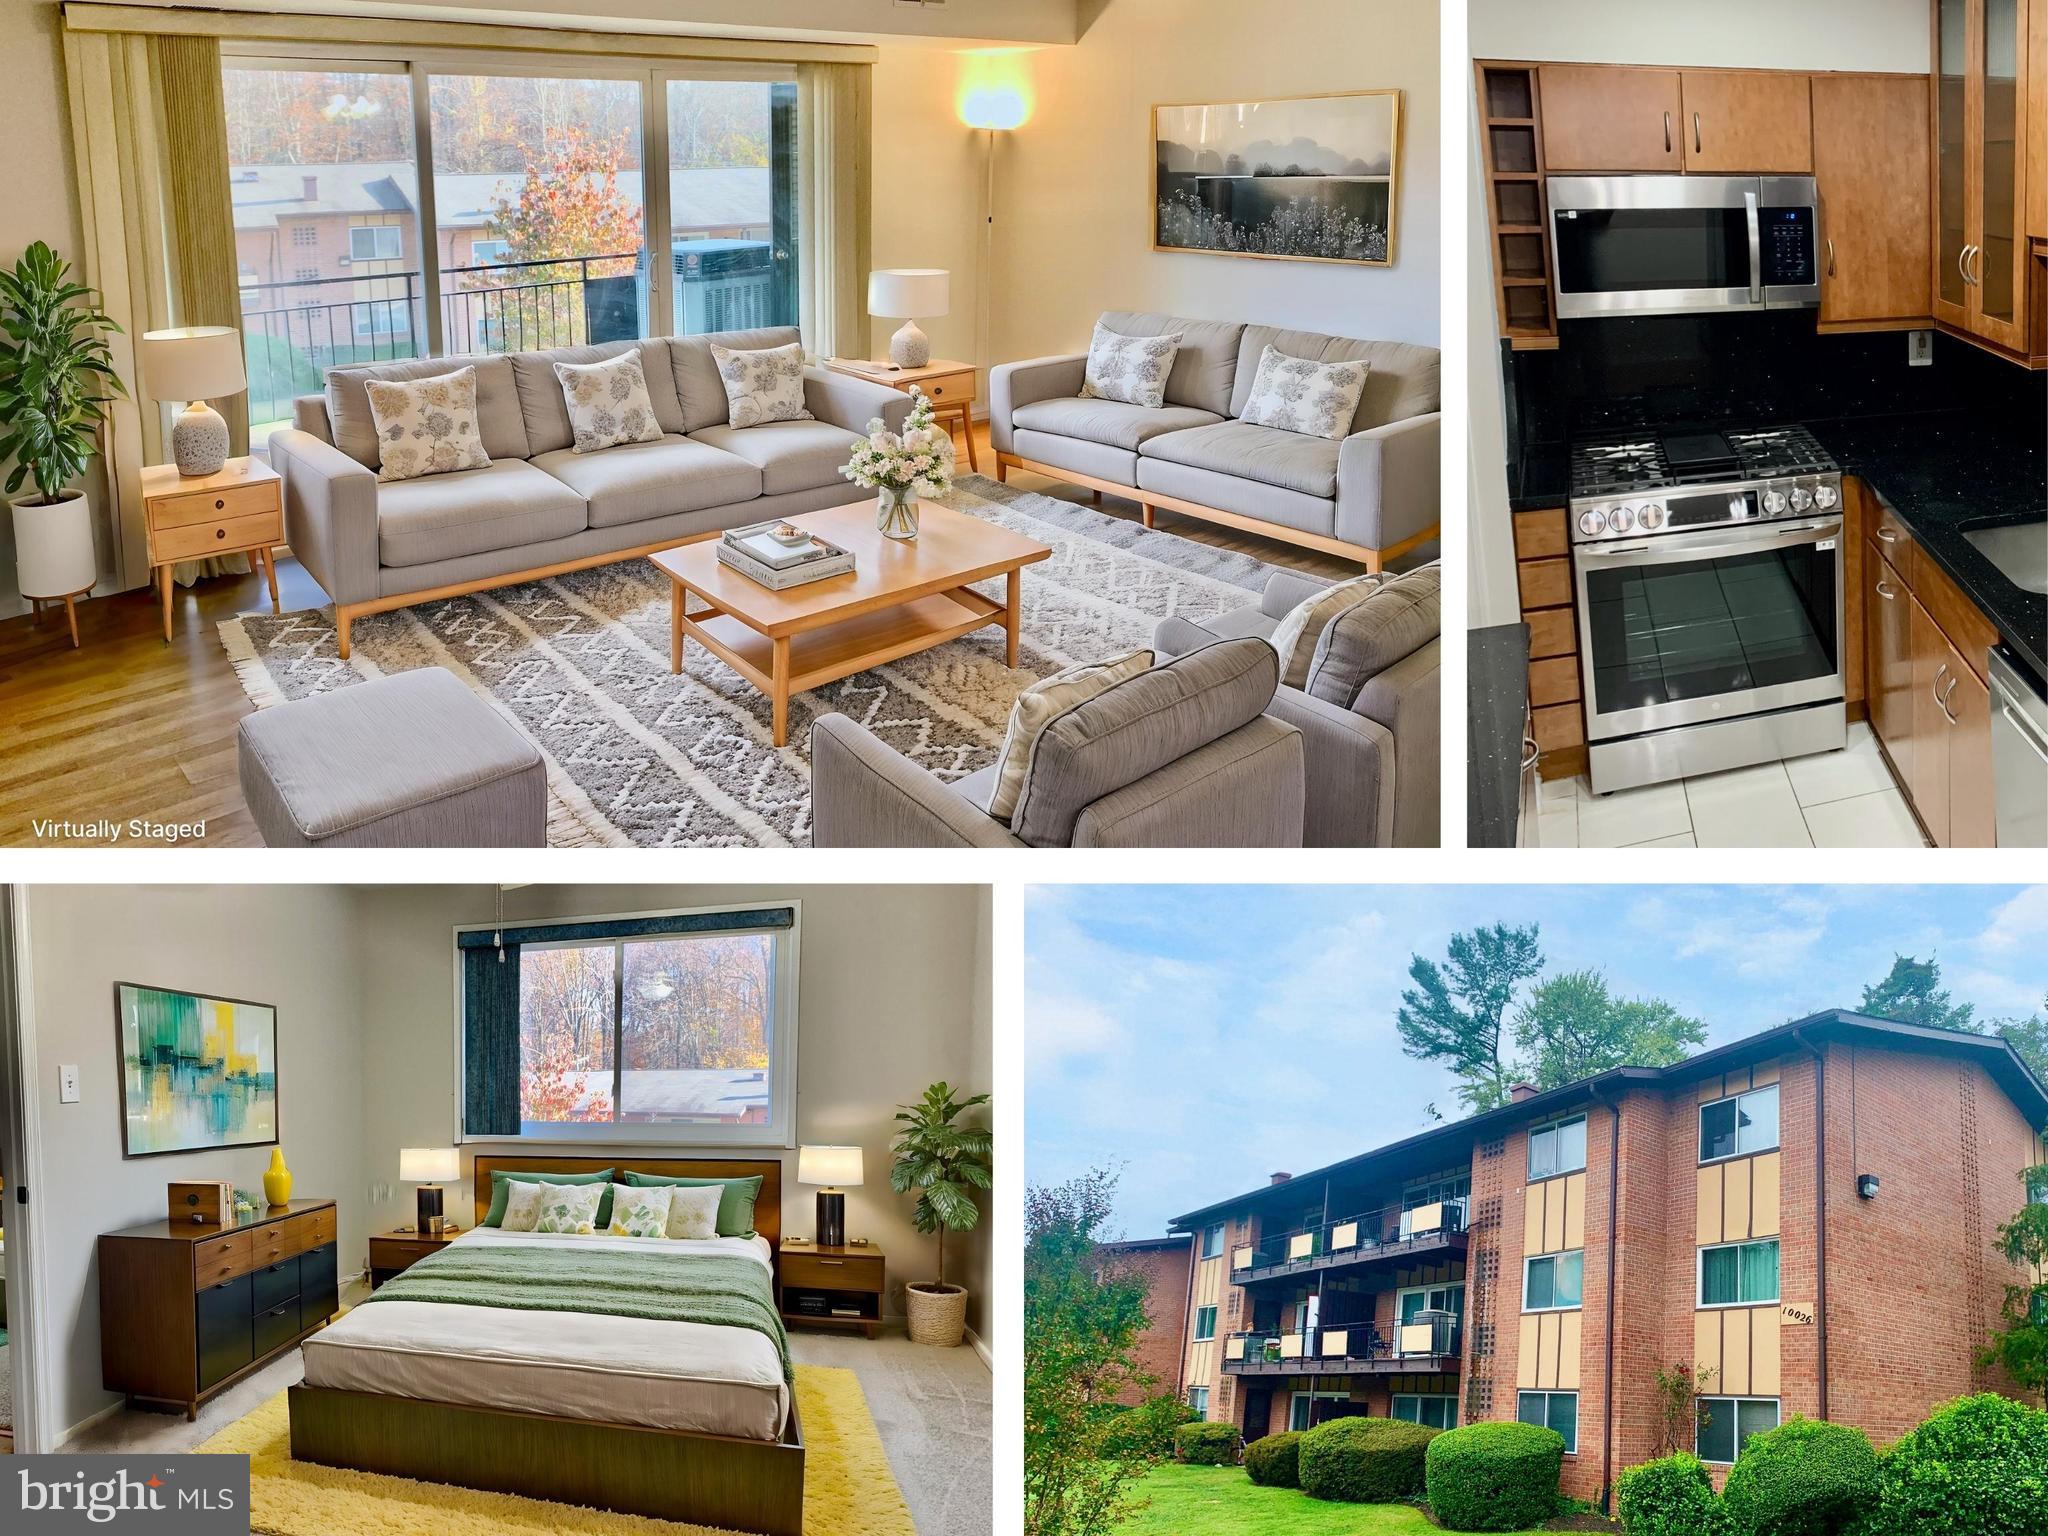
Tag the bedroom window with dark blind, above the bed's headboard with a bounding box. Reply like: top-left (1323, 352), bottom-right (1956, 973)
top-left (457, 907), bottom-right (797, 1147)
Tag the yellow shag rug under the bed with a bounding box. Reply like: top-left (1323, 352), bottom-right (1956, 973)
top-left (199, 1366), bottom-right (915, 1536)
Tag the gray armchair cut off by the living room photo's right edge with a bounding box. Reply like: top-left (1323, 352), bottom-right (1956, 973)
top-left (1153, 565), bottom-right (1442, 848)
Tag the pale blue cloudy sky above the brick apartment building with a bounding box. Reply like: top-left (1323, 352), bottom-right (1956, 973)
top-left (1024, 885), bottom-right (2048, 1237)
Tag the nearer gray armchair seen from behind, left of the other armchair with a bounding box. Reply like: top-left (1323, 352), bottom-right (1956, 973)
top-left (811, 639), bottom-right (1305, 848)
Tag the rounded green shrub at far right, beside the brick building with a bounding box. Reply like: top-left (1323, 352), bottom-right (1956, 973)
top-left (1870, 1393), bottom-right (2048, 1536)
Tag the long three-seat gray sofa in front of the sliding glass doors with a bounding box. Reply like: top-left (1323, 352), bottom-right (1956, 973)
top-left (270, 328), bottom-right (909, 657)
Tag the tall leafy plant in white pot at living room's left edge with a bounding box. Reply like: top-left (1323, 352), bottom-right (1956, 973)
top-left (0, 240), bottom-right (127, 643)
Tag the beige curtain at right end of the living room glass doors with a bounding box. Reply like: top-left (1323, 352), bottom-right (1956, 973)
top-left (797, 63), bottom-right (874, 356)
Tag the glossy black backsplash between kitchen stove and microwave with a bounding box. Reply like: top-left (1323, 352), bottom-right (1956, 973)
top-left (1503, 309), bottom-right (2048, 483)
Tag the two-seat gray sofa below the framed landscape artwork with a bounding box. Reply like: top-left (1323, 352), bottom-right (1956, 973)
top-left (989, 311), bottom-right (1440, 571)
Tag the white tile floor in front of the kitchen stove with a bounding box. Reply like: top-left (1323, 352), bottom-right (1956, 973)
top-left (1536, 721), bottom-right (1923, 848)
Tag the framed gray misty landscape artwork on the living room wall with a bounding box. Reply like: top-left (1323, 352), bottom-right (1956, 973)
top-left (1153, 90), bottom-right (1401, 266)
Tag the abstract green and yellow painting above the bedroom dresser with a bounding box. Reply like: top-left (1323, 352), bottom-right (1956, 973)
top-left (115, 981), bottom-right (276, 1157)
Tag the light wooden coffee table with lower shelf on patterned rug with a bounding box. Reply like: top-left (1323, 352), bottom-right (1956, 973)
top-left (651, 498), bottom-right (1053, 748)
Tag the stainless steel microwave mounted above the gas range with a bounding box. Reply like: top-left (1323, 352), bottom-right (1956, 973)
top-left (1548, 176), bottom-right (1821, 319)
